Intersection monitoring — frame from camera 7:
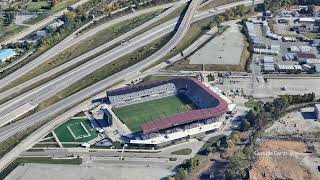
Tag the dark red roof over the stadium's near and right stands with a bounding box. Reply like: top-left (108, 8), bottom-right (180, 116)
top-left (141, 78), bottom-right (228, 133)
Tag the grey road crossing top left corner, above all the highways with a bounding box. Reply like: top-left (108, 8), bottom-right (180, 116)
top-left (0, 0), bottom-right (89, 45)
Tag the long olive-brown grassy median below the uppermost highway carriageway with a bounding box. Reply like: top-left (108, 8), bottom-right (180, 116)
top-left (0, 11), bottom-right (160, 91)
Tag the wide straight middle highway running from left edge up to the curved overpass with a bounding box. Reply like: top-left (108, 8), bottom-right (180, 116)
top-left (0, 5), bottom-right (182, 124)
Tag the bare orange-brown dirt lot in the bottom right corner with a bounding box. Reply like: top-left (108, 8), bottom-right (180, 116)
top-left (250, 140), bottom-right (320, 180)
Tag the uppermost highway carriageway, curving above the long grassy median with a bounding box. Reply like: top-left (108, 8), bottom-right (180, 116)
top-left (0, 1), bottom-right (180, 88)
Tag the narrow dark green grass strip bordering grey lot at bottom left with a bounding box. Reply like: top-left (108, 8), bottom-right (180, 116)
top-left (0, 157), bottom-right (82, 179)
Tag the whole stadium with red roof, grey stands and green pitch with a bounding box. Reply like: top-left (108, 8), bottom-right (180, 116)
top-left (107, 77), bottom-right (228, 146)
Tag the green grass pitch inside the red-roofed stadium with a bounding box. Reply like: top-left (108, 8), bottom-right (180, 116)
top-left (113, 96), bottom-right (192, 132)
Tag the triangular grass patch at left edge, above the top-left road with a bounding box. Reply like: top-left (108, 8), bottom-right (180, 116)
top-left (0, 17), bottom-right (27, 42)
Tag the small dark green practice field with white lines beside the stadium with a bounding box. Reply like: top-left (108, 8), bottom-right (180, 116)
top-left (54, 118), bottom-right (98, 142)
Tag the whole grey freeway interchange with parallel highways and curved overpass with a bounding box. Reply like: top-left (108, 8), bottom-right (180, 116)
top-left (0, 0), bottom-right (263, 175)
